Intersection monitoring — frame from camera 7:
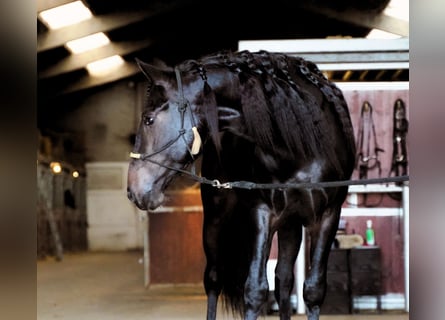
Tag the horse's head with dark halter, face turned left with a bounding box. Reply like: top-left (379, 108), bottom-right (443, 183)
top-left (127, 61), bottom-right (202, 210)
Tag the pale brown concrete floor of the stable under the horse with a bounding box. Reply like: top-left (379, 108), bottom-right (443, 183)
top-left (37, 252), bottom-right (409, 320)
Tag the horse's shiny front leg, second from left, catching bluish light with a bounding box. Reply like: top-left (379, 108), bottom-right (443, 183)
top-left (244, 205), bottom-right (271, 320)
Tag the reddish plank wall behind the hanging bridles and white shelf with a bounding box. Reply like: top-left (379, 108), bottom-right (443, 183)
top-left (343, 88), bottom-right (409, 293)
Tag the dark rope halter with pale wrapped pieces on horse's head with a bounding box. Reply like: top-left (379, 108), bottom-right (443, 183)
top-left (130, 68), bottom-right (201, 162)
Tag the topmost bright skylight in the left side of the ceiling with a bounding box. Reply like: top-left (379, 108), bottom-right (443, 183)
top-left (38, 1), bottom-right (93, 29)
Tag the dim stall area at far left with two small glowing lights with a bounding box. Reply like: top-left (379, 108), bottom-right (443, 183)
top-left (36, 135), bottom-right (88, 260)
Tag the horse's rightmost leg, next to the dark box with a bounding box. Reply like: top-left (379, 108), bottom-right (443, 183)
top-left (303, 206), bottom-right (341, 320)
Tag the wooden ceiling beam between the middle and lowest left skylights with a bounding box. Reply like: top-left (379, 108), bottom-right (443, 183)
top-left (38, 39), bottom-right (153, 79)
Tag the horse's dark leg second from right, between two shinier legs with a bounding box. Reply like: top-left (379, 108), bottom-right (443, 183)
top-left (275, 220), bottom-right (302, 320)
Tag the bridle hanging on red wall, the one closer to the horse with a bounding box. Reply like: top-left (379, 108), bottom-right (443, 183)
top-left (357, 101), bottom-right (384, 179)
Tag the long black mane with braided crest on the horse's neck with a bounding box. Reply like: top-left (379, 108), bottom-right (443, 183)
top-left (178, 51), bottom-right (355, 172)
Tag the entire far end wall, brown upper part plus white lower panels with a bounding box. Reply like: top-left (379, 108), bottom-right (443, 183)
top-left (45, 80), bottom-right (145, 251)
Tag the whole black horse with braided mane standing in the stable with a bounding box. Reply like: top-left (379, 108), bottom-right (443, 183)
top-left (128, 51), bottom-right (355, 320)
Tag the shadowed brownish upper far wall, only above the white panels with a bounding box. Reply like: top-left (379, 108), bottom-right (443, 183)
top-left (57, 81), bottom-right (144, 162)
